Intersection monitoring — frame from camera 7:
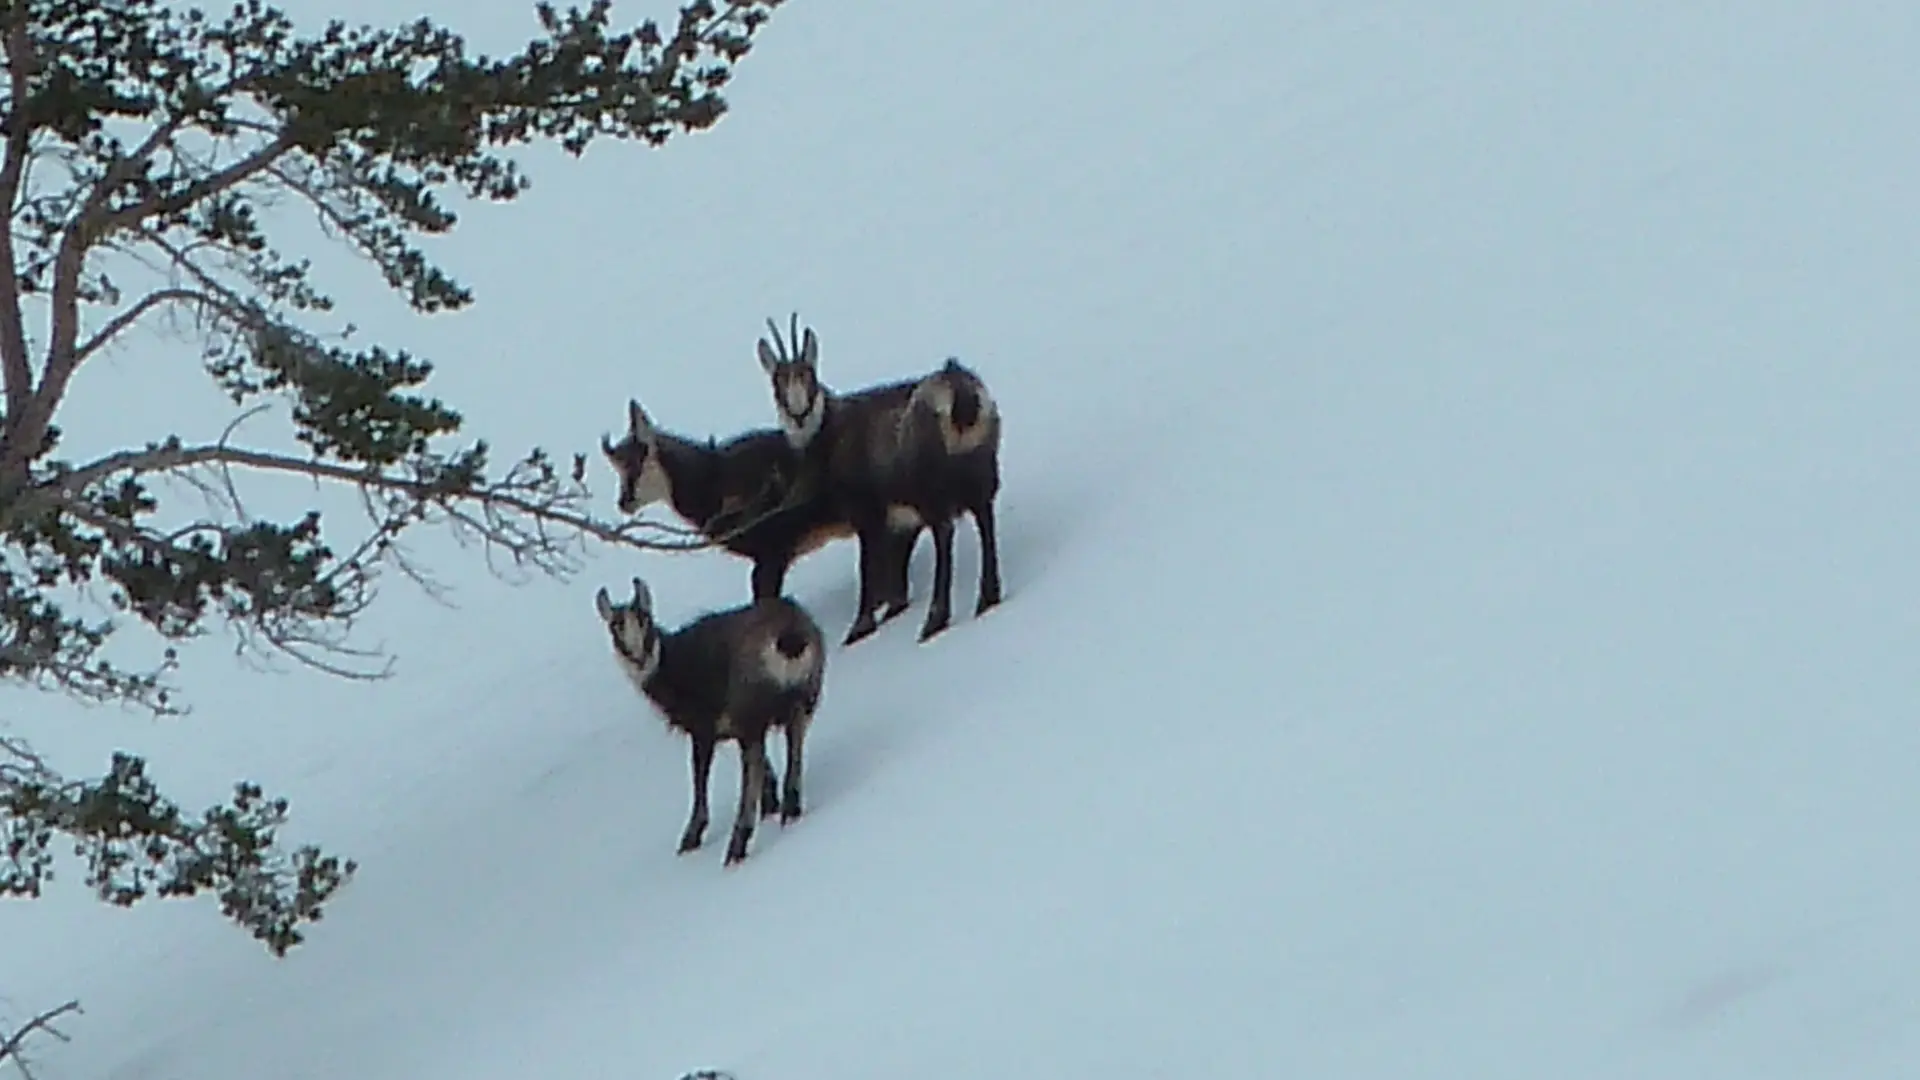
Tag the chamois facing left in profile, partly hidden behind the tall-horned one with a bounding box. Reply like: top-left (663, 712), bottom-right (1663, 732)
top-left (601, 400), bottom-right (854, 600)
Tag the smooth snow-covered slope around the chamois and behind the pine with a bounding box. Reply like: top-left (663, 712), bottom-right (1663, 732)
top-left (11, 0), bottom-right (1920, 1080)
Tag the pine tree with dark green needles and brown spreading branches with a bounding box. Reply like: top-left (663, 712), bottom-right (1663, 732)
top-left (0, 0), bottom-right (781, 951)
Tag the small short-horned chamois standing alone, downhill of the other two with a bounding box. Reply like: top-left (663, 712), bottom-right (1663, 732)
top-left (593, 578), bottom-right (826, 865)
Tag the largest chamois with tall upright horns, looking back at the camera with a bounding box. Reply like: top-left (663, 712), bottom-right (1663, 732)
top-left (758, 313), bottom-right (1000, 646)
